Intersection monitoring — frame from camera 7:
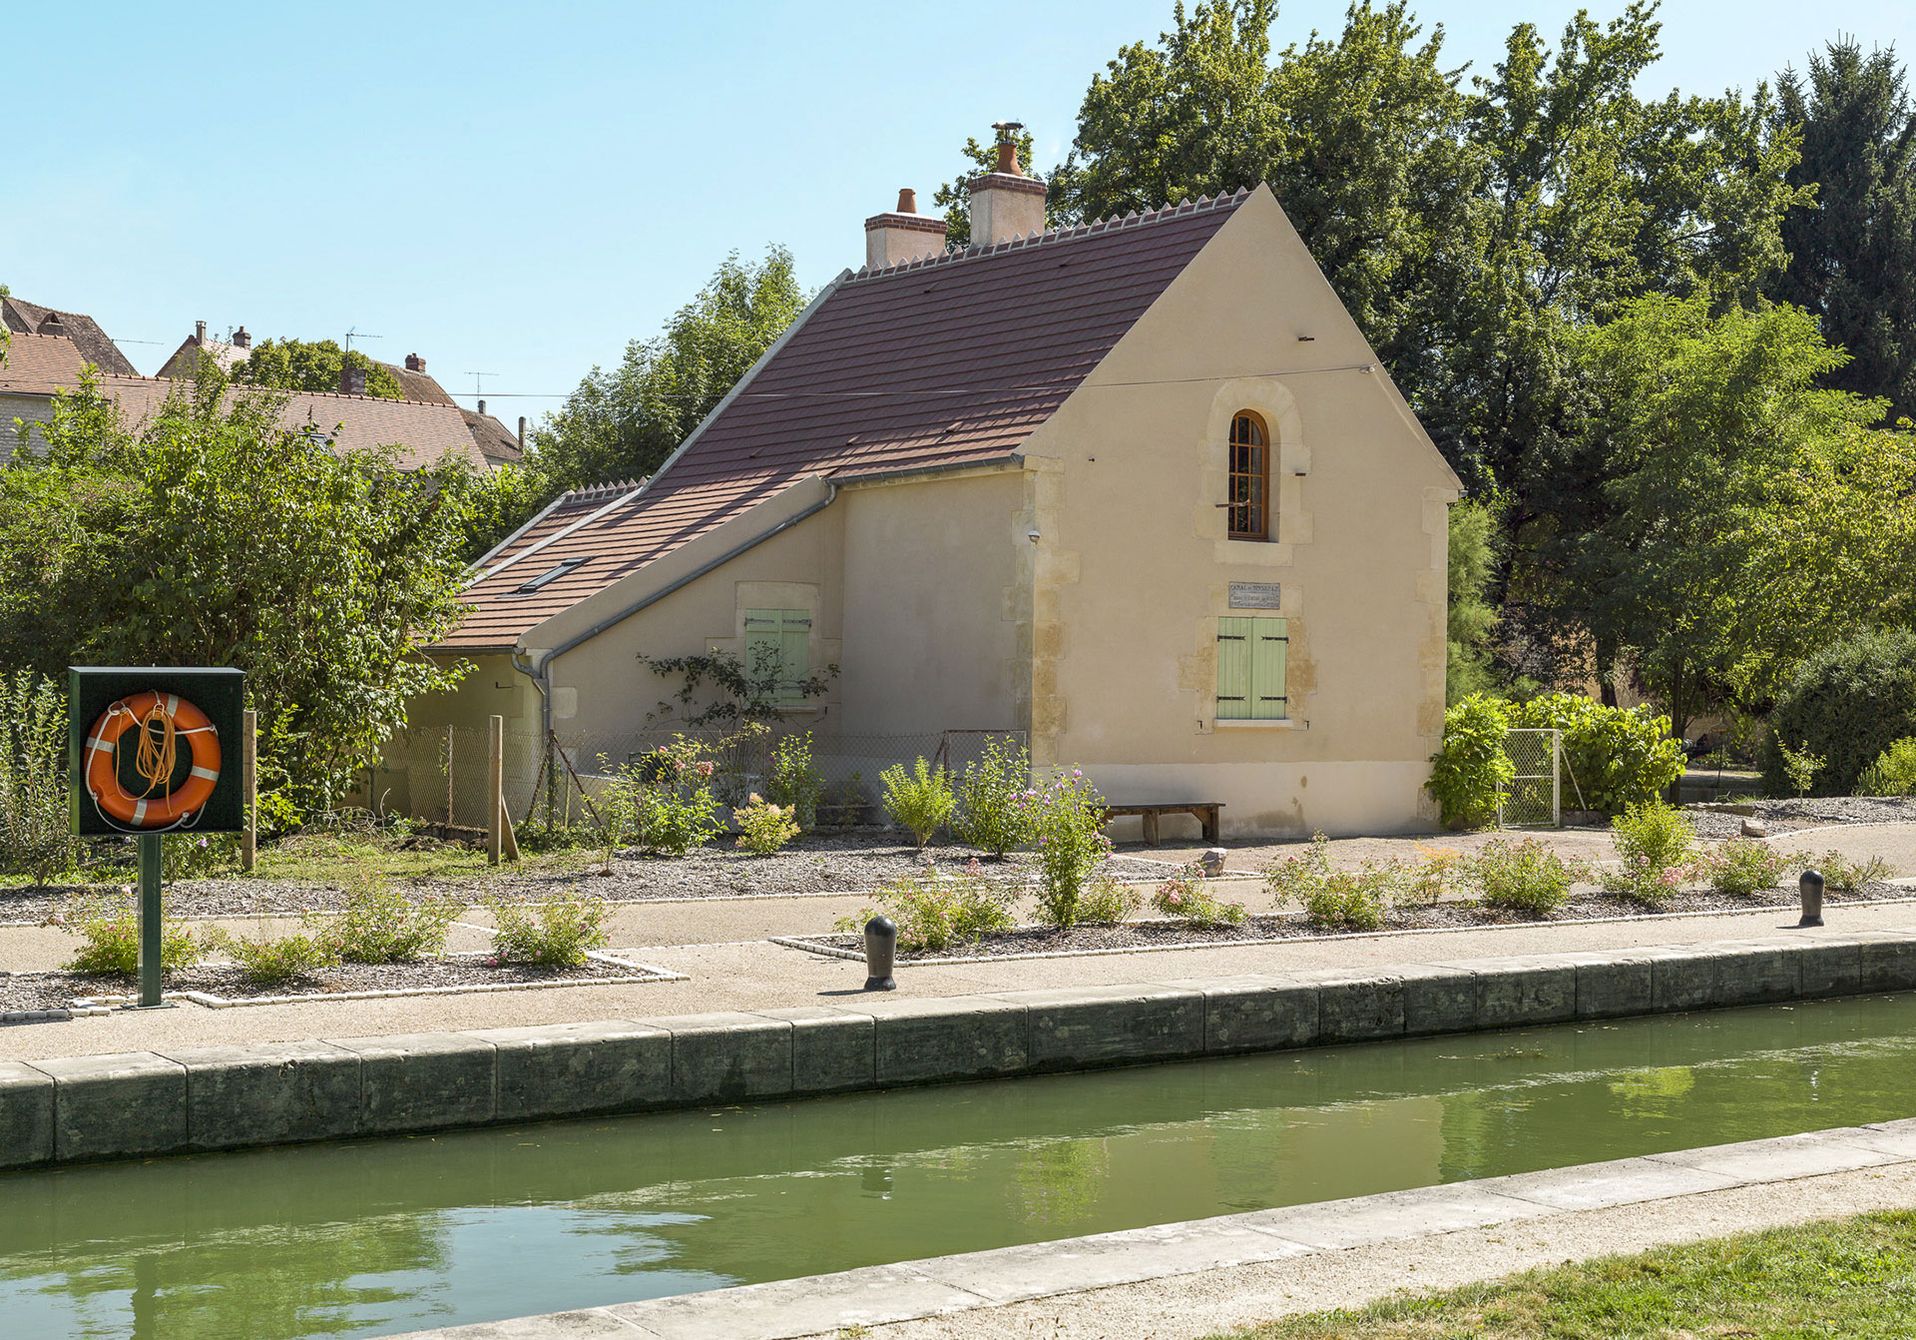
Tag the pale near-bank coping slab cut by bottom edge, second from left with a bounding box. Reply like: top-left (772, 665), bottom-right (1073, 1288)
top-left (604, 1265), bottom-right (985, 1340)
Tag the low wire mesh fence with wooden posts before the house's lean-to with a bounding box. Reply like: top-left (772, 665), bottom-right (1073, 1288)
top-left (366, 723), bottom-right (1025, 830)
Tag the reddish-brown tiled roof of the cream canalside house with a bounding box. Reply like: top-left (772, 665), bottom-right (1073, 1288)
top-left (443, 190), bottom-right (1249, 650)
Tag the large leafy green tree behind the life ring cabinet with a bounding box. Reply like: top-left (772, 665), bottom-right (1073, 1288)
top-left (0, 374), bottom-right (466, 809)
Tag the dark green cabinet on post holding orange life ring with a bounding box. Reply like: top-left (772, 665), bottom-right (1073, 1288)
top-left (67, 665), bottom-right (245, 1008)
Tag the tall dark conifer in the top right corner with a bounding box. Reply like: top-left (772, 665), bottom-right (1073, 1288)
top-left (1770, 38), bottom-right (1916, 416)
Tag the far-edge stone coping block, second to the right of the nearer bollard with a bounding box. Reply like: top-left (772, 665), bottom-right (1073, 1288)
top-left (998, 985), bottom-right (1205, 1070)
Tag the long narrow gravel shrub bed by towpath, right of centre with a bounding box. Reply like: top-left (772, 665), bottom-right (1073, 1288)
top-left (774, 884), bottom-right (1912, 962)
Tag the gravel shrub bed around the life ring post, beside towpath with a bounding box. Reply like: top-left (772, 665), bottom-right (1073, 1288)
top-left (0, 955), bottom-right (680, 1014)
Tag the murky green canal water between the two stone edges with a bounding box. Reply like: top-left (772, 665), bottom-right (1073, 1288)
top-left (11, 997), bottom-right (1916, 1340)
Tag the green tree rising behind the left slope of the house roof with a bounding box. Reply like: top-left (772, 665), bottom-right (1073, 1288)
top-left (533, 247), bottom-right (805, 489)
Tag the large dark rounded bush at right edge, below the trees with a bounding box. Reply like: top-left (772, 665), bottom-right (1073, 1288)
top-left (1757, 629), bottom-right (1916, 796)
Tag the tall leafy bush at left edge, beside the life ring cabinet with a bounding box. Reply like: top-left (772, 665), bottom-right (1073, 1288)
top-left (0, 669), bottom-right (80, 886)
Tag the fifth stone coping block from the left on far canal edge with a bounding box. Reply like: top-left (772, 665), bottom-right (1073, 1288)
top-left (466, 1020), bottom-right (673, 1121)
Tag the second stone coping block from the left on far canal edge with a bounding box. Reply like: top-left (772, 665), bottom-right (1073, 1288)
top-left (34, 1052), bottom-right (186, 1162)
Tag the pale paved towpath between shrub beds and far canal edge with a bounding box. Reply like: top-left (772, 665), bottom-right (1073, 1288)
top-left (0, 903), bottom-right (1916, 1060)
